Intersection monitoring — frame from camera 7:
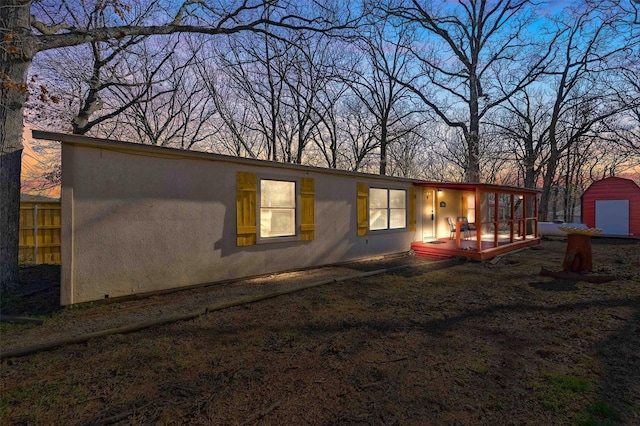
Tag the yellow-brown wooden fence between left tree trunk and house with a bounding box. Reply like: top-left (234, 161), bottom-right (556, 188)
top-left (19, 201), bottom-right (61, 264)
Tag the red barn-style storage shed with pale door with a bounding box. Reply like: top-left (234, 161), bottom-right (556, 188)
top-left (582, 177), bottom-right (640, 237)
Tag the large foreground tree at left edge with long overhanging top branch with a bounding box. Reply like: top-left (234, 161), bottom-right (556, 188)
top-left (0, 0), bottom-right (360, 288)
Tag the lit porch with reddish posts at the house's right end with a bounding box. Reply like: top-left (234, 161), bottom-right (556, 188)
top-left (411, 183), bottom-right (540, 260)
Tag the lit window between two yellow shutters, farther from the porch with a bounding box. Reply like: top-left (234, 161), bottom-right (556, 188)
top-left (260, 179), bottom-right (296, 238)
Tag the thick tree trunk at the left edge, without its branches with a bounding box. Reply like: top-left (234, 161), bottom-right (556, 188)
top-left (0, 0), bottom-right (33, 290)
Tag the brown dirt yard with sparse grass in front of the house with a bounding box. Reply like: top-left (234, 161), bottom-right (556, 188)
top-left (0, 239), bottom-right (640, 425)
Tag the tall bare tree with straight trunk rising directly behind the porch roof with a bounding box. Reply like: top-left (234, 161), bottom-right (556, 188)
top-left (384, 0), bottom-right (553, 182)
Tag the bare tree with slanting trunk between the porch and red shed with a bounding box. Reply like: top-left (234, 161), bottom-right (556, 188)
top-left (539, 1), bottom-right (638, 220)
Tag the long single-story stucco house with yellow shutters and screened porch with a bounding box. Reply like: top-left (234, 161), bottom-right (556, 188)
top-left (33, 131), bottom-right (539, 305)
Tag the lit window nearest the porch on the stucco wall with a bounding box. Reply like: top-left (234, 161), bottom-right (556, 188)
top-left (369, 188), bottom-right (407, 231)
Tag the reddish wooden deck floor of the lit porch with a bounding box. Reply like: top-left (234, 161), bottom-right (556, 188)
top-left (411, 237), bottom-right (540, 260)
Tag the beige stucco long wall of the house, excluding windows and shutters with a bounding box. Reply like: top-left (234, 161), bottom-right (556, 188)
top-left (61, 143), bottom-right (422, 304)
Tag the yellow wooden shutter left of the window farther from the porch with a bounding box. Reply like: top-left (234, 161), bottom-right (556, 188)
top-left (236, 172), bottom-right (258, 247)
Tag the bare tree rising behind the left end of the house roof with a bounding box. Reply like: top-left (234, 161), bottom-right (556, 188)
top-left (24, 2), bottom-right (176, 134)
